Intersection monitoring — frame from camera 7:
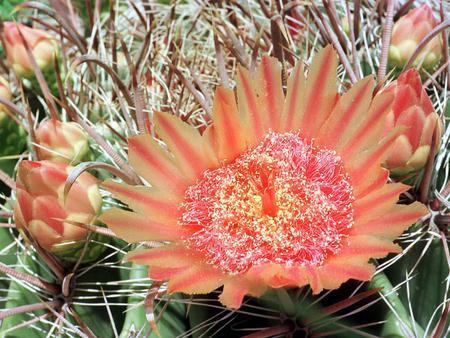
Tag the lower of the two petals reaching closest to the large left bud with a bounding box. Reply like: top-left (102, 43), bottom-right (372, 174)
top-left (99, 208), bottom-right (195, 243)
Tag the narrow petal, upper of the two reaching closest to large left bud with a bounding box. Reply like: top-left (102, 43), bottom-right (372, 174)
top-left (102, 179), bottom-right (181, 222)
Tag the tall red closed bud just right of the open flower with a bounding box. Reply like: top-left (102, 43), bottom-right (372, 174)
top-left (383, 69), bottom-right (443, 175)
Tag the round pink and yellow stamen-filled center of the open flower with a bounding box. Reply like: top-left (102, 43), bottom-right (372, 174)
top-left (179, 132), bottom-right (354, 274)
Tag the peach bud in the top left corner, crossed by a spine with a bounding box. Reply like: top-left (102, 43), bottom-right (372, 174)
top-left (3, 22), bottom-right (58, 77)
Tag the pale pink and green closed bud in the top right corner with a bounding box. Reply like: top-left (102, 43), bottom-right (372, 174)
top-left (389, 4), bottom-right (442, 70)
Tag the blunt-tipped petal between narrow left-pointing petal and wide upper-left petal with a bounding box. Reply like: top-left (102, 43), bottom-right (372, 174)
top-left (128, 134), bottom-right (192, 195)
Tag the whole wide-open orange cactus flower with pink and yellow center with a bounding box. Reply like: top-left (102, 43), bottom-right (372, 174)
top-left (100, 47), bottom-right (427, 308)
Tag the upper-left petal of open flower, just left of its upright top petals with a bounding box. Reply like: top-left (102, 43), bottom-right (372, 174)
top-left (153, 112), bottom-right (217, 180)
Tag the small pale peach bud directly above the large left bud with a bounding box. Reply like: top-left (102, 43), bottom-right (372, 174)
top-left (36, 119), bottom-right (89, 163)
